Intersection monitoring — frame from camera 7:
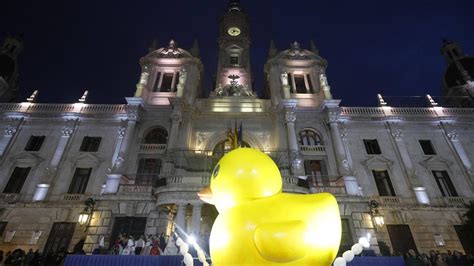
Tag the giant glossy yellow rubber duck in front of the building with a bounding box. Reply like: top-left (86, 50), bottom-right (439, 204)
top-left (198, 148), bottom-right (341, 266)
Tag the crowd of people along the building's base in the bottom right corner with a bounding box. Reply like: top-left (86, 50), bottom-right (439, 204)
top-left (404, 249), bottom-right (474, 266)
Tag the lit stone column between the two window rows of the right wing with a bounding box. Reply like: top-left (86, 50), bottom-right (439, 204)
top-left (387, 123), bottom-right (430, 204)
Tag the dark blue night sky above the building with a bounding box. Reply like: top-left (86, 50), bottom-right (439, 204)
top-left (0, 0), bottom-right (474, 106)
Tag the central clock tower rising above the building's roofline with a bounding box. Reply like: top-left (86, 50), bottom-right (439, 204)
top-left (215, 0), bottom-right (254, 96)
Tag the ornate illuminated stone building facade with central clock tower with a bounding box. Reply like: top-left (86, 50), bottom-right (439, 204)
top-left (0, 1), bottom-right (474, 252)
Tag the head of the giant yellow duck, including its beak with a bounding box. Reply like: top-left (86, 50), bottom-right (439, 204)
top-left (198, 148), bottom-right (282, 212)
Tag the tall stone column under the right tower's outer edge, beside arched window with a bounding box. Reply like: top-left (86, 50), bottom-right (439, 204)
top-left (328, 110), bottom-right (360, 196)
